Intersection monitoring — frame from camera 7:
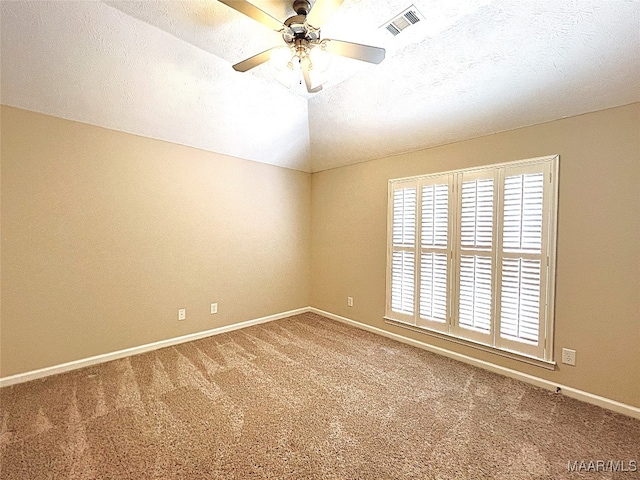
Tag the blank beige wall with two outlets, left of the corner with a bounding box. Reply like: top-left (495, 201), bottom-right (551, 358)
top-left (0, 106), bottom-right (311, 377)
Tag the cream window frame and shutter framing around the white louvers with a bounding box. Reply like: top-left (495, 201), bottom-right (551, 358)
top-left (384, 155), bottom-right (560, 368)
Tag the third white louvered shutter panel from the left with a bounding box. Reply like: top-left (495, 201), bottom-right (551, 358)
top-left (457, 170), bottom-right (495, 342)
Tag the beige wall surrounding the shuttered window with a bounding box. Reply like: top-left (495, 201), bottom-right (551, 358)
top-left (311, 104), bottom-right (640, 407)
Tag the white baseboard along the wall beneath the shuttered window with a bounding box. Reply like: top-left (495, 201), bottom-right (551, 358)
top-left (308, 307), bottom-right (640, 420)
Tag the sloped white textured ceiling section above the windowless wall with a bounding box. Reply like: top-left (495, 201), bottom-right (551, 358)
top-left (1, 1), bottom-right (311, 171)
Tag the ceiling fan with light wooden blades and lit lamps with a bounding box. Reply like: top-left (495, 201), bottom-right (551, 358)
top-left (218, 0), bottom-right (385, 93)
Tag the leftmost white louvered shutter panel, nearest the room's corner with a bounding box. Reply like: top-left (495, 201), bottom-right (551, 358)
top-left (391, 182), bottom-right (418, 316)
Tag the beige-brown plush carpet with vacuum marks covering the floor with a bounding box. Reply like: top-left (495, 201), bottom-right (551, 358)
top-left (0, 314), bottom-right (640, 480)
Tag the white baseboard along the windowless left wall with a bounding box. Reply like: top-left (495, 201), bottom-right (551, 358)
top-left (0, 307), bottom-right (310, 388)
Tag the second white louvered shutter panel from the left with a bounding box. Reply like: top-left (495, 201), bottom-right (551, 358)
top-left (418, 176), bottom-right (450, 330)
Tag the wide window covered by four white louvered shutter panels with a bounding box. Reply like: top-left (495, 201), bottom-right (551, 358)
top-left (386, 155), bottom-right (558, 362)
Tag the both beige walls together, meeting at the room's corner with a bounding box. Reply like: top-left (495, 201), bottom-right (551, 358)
top-left (0, 104), bottom-right (640, 406)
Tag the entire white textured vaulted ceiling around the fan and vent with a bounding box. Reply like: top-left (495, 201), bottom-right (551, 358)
top-left (0, 0), bottom-right (640, 172)
